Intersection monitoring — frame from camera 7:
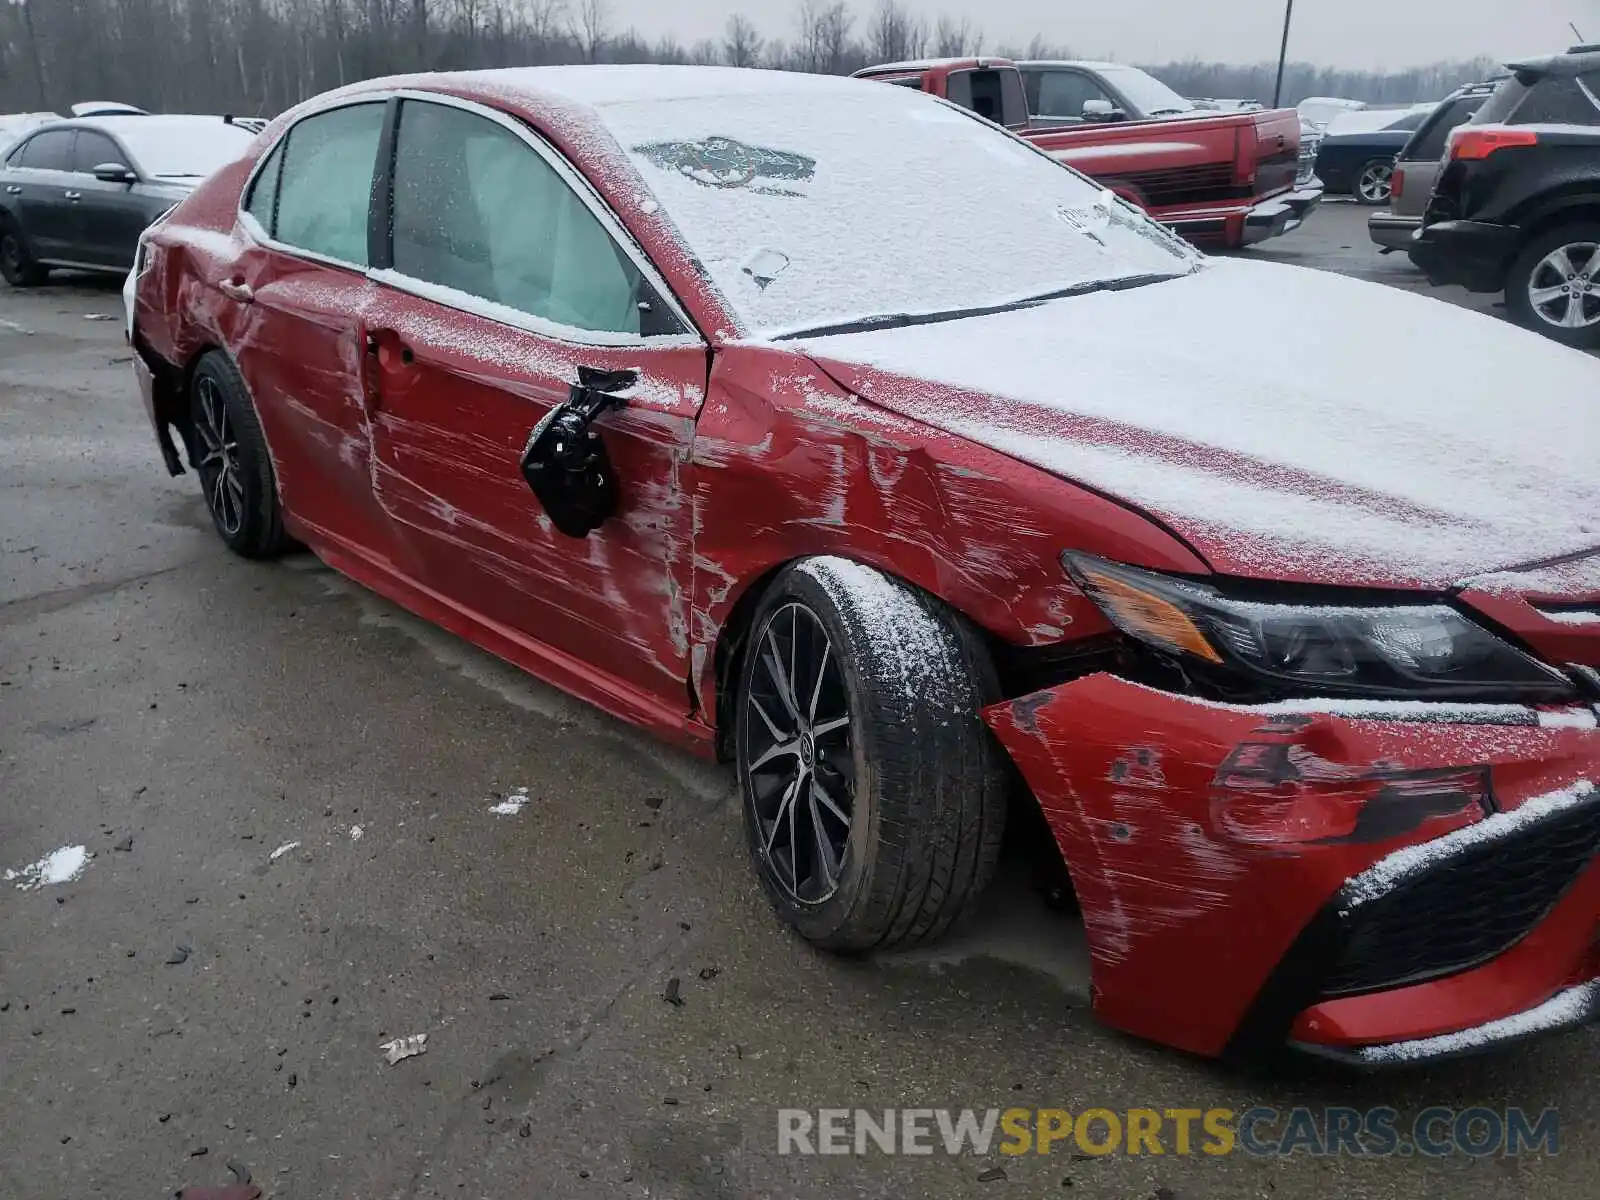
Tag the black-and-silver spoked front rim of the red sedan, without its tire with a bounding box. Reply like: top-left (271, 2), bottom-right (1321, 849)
top-left (741, 603), bottom-right (856, 904)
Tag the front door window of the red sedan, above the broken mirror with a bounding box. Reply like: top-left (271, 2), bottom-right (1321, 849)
top-left (390, 101), bottom-right (643, 334)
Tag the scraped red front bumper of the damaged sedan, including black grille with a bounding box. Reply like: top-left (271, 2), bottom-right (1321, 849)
top-left (984, 675), bottom-right (1600, 1064)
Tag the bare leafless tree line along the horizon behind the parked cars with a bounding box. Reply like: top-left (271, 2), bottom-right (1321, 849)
top-left (0, 0), bottom-right (1494, 115)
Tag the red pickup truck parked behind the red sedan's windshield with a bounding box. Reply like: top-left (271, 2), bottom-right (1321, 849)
top-left (856, 58), bottom-right (1322, 248)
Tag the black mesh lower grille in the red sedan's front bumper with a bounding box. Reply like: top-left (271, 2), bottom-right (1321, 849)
top-left (1322, 794), bottom-right (1600, 998)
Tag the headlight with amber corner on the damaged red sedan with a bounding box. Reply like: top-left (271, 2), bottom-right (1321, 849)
top-left (1061, 550), bottom-right (1574, 701)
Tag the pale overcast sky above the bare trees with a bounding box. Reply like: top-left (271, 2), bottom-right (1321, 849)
top-left (610, 0), bottom-right (1600, 67)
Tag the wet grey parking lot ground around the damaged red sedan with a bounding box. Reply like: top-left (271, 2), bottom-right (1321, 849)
top-left (0, 205), bottom-right (1600, 1200)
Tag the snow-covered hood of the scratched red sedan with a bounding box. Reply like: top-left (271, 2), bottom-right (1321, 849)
top-left (800, 261), bottom-right (1600, 587)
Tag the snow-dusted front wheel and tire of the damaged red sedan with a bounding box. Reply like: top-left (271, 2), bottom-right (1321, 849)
top-left (734, 558), bottom-right (1006, 952)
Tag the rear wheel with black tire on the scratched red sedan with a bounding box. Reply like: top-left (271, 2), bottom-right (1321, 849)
top-left (189, 350), bottom-right (293, 558)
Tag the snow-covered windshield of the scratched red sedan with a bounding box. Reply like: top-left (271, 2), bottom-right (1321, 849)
top-left (598, 77), bottom-right (1202, 336)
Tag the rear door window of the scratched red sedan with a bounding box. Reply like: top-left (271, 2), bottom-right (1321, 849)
top-left (273, 102), bottom-right (384, 267)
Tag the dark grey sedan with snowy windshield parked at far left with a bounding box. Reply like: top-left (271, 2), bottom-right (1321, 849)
top-left (0, 114), bottom-right (256, 288)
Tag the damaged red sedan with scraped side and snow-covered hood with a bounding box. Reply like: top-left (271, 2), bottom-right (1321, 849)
top-left (130, 67), bottom-right (1600, 1066)
